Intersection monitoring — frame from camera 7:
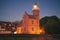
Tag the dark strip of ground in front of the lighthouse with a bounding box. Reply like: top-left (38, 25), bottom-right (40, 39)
top-left (0, 34), bottom-right (60, 40)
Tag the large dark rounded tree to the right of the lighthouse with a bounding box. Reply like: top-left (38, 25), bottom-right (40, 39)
top-left (40, 16), bottom-right (60, 34)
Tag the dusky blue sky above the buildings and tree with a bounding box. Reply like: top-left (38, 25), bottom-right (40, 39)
top-left (0, 0), bottom-right (60, 21)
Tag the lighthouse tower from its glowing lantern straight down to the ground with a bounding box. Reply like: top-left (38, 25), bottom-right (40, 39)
top-left (32, 3), bottom-right (40, 34)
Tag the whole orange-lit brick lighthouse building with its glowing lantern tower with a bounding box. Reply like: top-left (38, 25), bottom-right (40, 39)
top-left (16, 3), bottom-right (40, 34)
